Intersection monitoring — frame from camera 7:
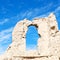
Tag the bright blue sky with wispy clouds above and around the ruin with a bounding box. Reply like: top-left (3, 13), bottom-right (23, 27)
top-left (0, 0), bottom-right (60, 54)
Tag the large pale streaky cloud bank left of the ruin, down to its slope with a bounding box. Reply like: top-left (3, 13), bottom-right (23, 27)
top-left (0, 27), bottom-right (13, 54)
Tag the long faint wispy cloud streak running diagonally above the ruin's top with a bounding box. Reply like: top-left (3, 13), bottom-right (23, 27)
top-left (11, 3), bottom-right (53, 20)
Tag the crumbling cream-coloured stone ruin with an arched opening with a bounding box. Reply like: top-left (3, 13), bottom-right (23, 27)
top-left (0, 13), bottom-right (60, 60)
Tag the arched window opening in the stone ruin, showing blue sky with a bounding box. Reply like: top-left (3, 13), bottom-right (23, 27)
top-left (26, 26), bottom-right (40, 50)
